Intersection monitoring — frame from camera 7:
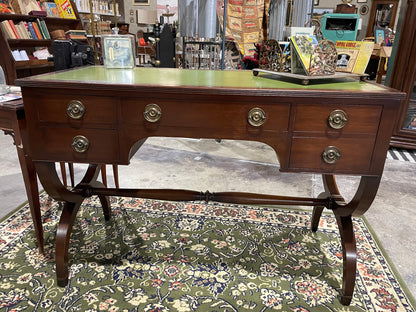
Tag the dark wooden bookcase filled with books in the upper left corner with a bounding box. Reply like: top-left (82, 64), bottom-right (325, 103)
top-left (0, 0), bottom-right (82, 85)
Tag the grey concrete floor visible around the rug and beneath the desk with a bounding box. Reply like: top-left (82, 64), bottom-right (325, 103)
top-left (0, 135), bottom-right (416, 296)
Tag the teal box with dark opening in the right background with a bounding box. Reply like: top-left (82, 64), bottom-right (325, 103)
top-left (321, 13), bottom-right (360, 42)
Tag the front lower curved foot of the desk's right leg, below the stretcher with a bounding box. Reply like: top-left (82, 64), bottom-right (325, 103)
top-left (335, 212), bottom-right (357, 305)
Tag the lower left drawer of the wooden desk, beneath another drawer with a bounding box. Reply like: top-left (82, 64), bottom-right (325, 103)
top-left (31, 127), bottom-right (119, 163)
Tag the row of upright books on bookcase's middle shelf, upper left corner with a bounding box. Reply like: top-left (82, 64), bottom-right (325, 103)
top-left (0, 18), bottom-right (51, 39)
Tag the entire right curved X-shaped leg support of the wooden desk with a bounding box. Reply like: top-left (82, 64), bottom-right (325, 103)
top-left (311, 175), bottom-right (381, 305)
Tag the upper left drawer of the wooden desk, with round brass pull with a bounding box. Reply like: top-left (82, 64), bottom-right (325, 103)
top-left (31, 94), bottom-right (117, 127)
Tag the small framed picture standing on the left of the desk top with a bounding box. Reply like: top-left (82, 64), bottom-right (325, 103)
top-left (103, 35), bottom-right (135, 68)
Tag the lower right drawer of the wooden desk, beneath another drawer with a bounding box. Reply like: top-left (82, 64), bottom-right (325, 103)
top-left (289, 137), bottom-right (374, 174)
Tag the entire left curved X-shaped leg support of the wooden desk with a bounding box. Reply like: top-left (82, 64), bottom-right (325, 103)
top-left (36, 162), bottom-right (111, 286)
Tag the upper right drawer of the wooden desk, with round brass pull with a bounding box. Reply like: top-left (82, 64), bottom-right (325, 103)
top-left (294, 104), bottom-right (382, 133)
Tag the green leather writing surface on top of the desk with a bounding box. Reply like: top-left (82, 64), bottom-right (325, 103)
top-left (22, 66), bottom-right (394, 92)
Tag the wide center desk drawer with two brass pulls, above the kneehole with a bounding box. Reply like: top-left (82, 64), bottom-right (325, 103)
top-left (121, 97), bottom-right (290, 131)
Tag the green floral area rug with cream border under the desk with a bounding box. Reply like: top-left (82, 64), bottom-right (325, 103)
top-left (0, 193), bottom-right (414, 312)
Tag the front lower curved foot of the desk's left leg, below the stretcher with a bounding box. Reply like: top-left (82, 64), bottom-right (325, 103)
top-left (55, 201), bottom-right (82, 287)
